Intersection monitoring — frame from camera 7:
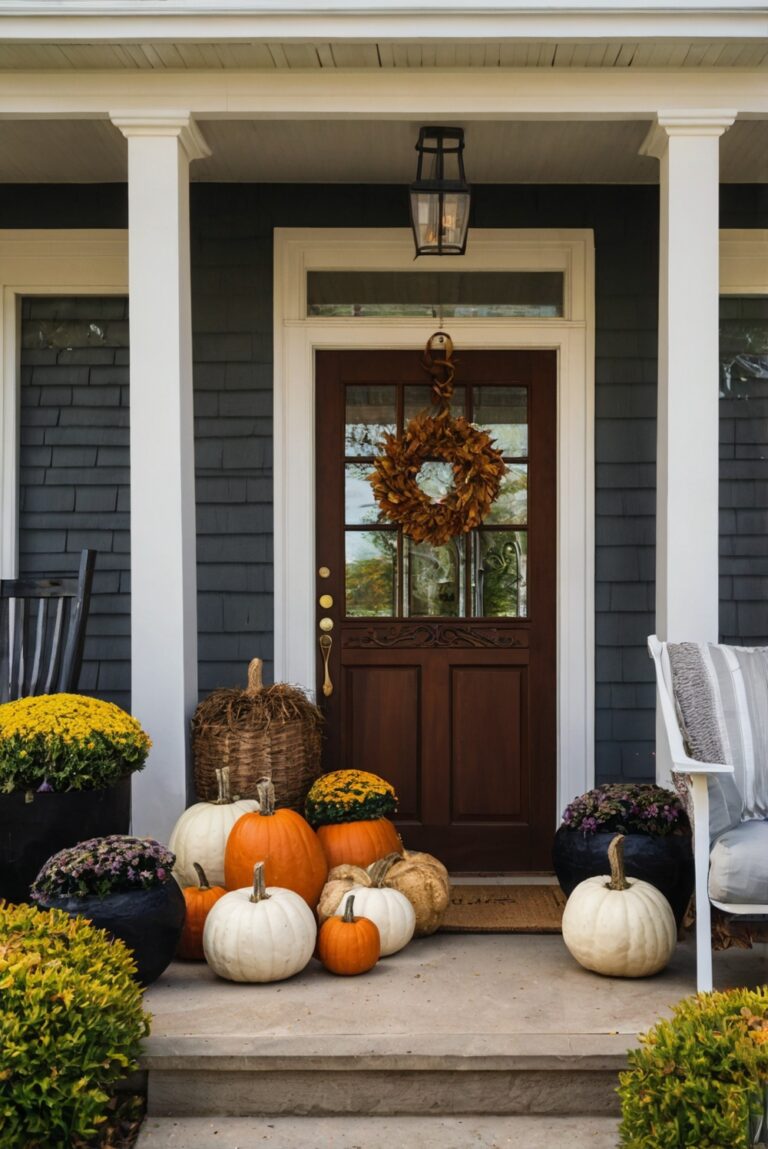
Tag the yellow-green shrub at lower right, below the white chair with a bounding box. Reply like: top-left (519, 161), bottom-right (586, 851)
top-left (619, 987), bottom-right (768, 1149)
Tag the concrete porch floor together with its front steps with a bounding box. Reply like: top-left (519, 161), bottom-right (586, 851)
top-left (139, 934), bottom-right (768, 1149)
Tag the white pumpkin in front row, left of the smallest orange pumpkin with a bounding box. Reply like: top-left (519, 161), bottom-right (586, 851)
top-left (202, 862), bottom-right (317, 981)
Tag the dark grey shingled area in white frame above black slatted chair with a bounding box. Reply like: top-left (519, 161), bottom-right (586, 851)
top-left (18, 296), bottom-right (131, 708)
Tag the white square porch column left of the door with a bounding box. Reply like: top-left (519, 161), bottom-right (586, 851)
top-left (112, 113), bottom-right (209, 842)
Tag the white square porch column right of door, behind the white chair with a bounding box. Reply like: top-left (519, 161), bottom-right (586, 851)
top-left (643, 111), bottom-right (736, 781)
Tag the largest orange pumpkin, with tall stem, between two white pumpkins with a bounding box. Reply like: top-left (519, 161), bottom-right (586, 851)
top-left (224, 781), bottom-right (328, 912)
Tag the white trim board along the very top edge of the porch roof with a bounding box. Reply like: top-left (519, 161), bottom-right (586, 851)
top-left (0, 0), bottom-right (768, 43)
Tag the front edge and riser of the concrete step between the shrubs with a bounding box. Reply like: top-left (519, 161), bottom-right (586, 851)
top-left (143, 1034), bottom-right (629, 1117)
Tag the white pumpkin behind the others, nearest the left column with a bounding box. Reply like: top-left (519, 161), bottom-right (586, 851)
top-left (168, 766), bottom-right (259, 889)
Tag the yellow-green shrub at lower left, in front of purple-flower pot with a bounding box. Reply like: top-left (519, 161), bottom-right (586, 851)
top-left (0, 902), bottom-right (148, 1149)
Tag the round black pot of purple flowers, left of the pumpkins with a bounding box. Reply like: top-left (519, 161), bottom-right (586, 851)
top-left (39, 878), bottom-right (186, 986)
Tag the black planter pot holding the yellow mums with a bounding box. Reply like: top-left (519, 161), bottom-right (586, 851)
top-left (0, 777), bottom-right (131, 902)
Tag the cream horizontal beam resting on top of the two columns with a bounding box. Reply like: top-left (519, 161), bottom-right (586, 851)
top-left (0, 68), bottom-right (768, 122)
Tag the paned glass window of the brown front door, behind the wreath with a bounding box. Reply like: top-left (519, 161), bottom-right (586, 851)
top-left (344, 383), bottom-right (529, 618)
